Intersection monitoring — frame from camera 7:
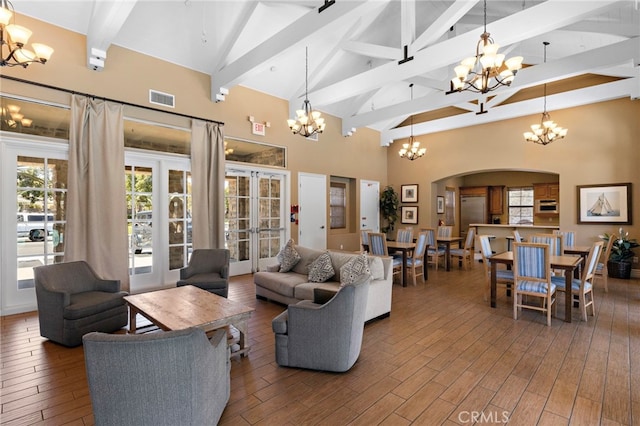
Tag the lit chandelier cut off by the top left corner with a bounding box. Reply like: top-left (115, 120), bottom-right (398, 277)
top-left (0, 0), bottom-right (53, 68)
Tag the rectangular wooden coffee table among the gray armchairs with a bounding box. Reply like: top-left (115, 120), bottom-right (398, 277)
top-left (124, 285), bottom-right (255, 356)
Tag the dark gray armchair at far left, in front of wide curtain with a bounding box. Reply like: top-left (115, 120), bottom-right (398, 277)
top-left (33, 261), bottom-right (129, 346)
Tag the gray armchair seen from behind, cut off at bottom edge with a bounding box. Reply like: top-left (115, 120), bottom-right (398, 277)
top-left (83, 328), bottom-right (231, 426)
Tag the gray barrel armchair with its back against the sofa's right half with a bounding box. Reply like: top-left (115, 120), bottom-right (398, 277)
top-left (271, 276), bottom-right (371, 372)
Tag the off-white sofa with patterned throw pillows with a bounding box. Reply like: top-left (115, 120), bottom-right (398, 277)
top-left (253, 246), bottom-right (393, 321)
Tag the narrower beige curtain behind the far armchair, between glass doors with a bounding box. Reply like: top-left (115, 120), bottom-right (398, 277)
top-left (191, 120), bottom-right (224, 249)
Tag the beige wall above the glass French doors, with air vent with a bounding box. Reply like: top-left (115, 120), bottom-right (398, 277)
top-left (0, 16), bottom-right (387, 250)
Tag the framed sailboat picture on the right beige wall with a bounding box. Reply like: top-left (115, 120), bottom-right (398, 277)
top-left (577, 183), bottom-right (632, 225)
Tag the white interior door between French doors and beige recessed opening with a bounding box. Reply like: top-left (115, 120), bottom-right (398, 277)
top-left (298, 173), bottom-right (327, 250)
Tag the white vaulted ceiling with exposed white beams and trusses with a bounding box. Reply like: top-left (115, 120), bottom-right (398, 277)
top-left (13, 0), bottom-right (640, 145)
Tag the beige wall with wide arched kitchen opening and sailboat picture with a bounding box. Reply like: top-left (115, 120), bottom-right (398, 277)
top-left (387, 99), bottom-right (640, 268)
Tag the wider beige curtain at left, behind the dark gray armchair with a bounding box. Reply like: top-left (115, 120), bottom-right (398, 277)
top-left (65, 95), bottom-right (129, 291)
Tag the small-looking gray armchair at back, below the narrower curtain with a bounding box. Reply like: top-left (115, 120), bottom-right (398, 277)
top-left (177, 249), bottom-right (230, 297)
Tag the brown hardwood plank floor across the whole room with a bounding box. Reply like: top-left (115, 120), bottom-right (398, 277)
top-left (0, 263), bottom-right (640, 425)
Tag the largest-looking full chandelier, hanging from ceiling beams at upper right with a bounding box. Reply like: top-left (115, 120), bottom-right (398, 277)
top-left (447, 0), bottom-right (522, 95)
